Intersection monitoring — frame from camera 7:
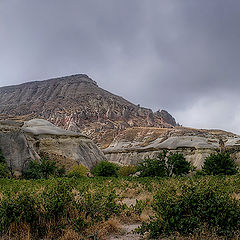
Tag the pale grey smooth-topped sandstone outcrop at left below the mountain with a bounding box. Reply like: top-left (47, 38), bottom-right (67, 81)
top-left (0, 119), bottom-right (105, 175)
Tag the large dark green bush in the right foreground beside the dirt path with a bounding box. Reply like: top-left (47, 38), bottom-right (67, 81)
top-left (138, 182), bottom-right (240, 239)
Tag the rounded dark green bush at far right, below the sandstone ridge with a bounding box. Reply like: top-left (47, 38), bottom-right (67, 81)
top-left (202, 152), bottom-right (238, 175)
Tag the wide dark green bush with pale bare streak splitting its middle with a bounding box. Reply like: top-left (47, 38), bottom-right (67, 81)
top-left (137, 150), bottom-right (191, 177)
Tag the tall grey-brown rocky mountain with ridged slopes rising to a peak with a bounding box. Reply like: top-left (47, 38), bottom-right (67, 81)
top-left (0, 74), bottom-right (176, 148)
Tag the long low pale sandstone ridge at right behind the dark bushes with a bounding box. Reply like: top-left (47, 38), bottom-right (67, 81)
top-left (103, 127), bottom-right (240, 169)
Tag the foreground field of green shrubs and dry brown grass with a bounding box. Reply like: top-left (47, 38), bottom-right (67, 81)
top-left (0, 175), bottom-right (240, 240)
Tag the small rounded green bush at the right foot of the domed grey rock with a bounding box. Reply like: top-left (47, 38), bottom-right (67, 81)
top-left (91, 161), bottom-right (119, 177)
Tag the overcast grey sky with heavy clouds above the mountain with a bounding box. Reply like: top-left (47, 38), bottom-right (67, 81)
top-left (0, 0), bottom-right (240, 134)
